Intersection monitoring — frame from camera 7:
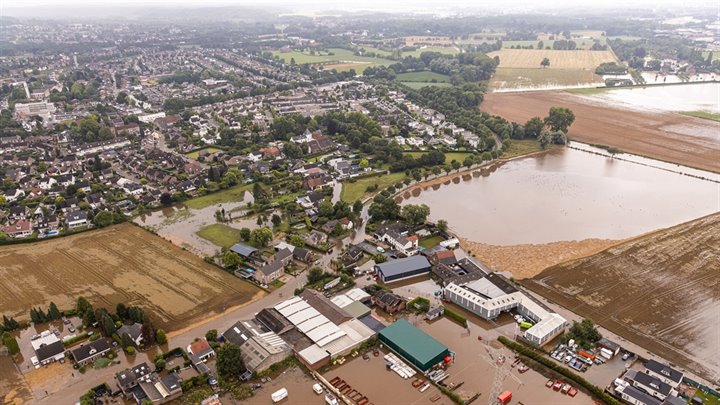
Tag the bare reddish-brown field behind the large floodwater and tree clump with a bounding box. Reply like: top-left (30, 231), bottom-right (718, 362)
top-left (480, 91), bottom-right (720, 173)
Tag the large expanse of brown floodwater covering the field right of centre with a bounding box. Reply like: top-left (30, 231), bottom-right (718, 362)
top-left (403, 148), bottom-right (720, 245)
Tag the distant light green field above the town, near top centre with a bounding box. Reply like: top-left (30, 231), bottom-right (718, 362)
top-left (273, 48), bottom-right (395, 73)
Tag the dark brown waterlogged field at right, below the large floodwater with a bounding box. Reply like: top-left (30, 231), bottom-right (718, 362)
top-left (524, 213), bottom-right (720, 383)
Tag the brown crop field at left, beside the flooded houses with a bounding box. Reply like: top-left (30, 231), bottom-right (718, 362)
top-left (0, 224), bottom-right (263, 330)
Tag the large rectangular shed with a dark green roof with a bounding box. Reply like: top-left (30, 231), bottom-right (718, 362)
top-left (379, 319), bottom-right (450, 372)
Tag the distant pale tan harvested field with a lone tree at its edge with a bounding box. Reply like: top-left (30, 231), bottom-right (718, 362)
top-left (488, 49), bottom-right (618, 71)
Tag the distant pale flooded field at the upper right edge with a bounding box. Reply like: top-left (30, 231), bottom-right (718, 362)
top-left (590, 79), bottom-right (720, 113)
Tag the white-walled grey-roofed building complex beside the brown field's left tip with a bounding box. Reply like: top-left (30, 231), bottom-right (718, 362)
top-left (444, 273), bottom-right (568, 346)
